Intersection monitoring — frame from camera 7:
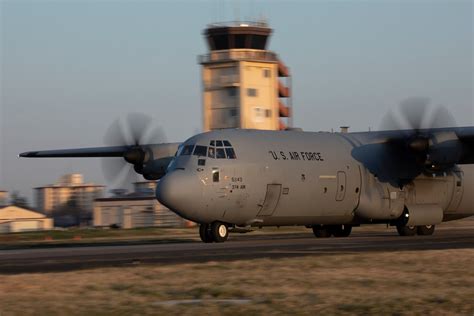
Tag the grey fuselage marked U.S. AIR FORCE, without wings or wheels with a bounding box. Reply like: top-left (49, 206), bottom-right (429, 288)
top-left (157, 130), bottom-right (474, 226)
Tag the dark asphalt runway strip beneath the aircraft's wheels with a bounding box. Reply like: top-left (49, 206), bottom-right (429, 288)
top-left (0, 228), bottom-right (474, 274)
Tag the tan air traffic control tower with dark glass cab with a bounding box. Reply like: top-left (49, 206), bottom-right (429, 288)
top-left (199, 22), bottom-right (292, 131)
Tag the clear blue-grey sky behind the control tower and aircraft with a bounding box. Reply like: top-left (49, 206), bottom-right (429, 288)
top-left (0, 0), bottom-right (474, 202)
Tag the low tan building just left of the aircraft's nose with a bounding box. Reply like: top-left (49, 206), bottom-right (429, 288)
top-left (93, 181), bottom-right (195, 228)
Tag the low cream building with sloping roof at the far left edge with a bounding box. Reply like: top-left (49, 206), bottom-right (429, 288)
top-left (0, 205), bottom-right (53, 233)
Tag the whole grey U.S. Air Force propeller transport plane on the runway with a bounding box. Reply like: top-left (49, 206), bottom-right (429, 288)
top-left (20, 102), bottom-right (474, 242)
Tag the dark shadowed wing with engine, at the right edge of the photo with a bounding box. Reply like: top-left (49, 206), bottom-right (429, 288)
top-left (347, 127), bottom-right (474, 186)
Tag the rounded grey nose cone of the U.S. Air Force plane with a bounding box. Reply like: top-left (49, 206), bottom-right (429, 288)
top-left (156, 170), bottom-right (202, 220)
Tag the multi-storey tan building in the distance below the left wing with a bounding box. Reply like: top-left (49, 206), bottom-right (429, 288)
top-left (35, 173), bottom-right (105, 215)
